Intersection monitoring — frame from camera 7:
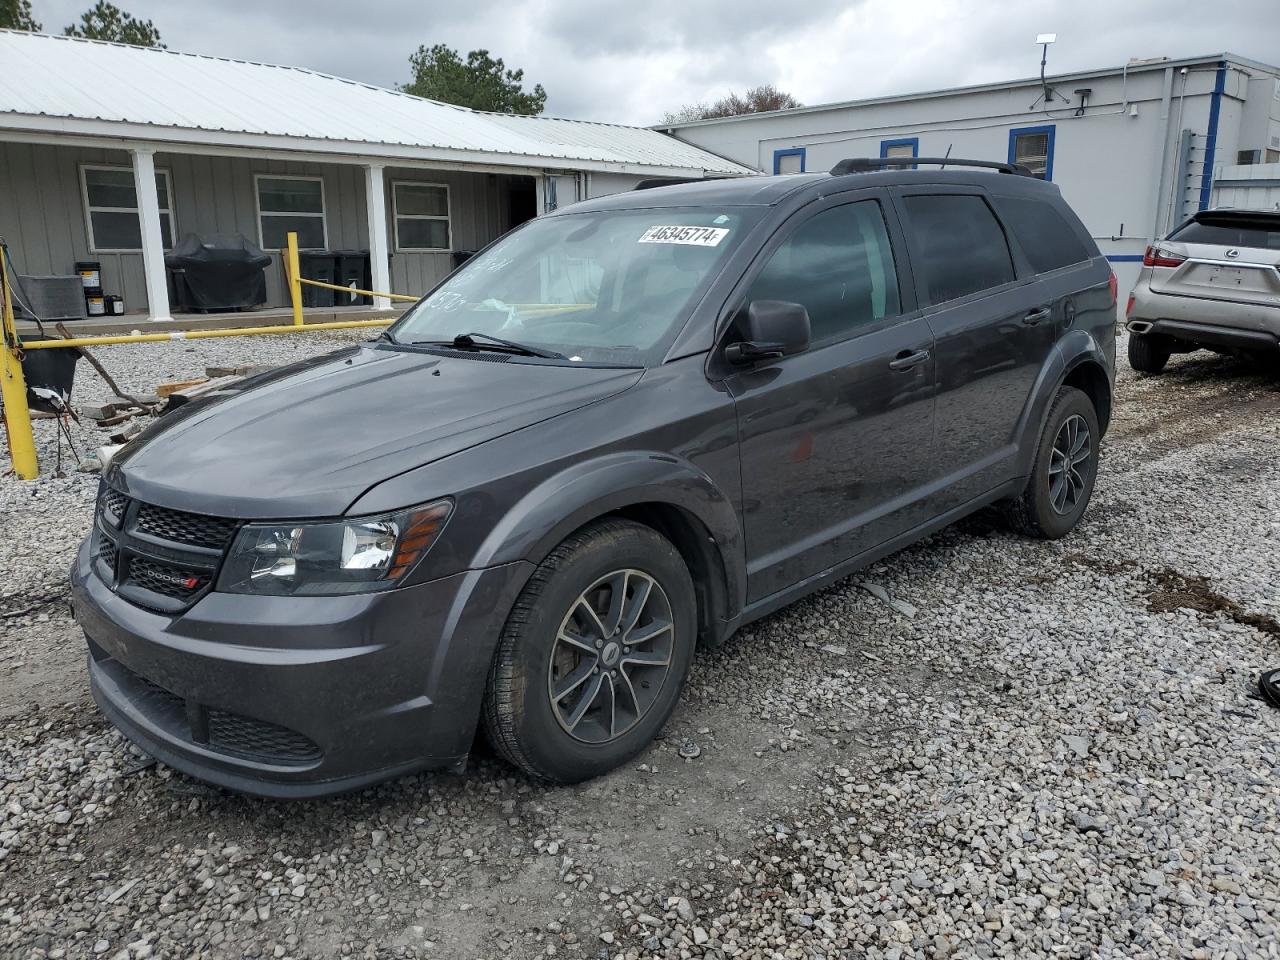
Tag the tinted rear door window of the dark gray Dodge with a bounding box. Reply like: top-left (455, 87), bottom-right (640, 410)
top-left (902, 195), bottom-right (1014, 303)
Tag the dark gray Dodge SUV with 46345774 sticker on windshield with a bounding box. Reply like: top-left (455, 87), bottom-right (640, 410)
top-left (72, 157), bottom-right (1115, 797)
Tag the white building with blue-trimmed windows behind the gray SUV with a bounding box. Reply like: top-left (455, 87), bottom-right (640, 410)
top-left (659, 54), bottom-right (1280, 289)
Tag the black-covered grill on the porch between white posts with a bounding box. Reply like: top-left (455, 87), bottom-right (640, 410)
top-left (164, 233), bottom-right (271, 311)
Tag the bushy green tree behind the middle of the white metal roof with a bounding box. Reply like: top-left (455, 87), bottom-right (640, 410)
top-left (401, 44), bottom-right (547, 116)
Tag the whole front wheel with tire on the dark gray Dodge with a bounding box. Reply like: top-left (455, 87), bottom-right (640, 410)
top-left (484, 520), bottom-right (698, 783)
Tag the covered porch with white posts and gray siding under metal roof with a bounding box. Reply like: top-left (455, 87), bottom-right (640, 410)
top-left (0, 140), bottom-right (545, 323)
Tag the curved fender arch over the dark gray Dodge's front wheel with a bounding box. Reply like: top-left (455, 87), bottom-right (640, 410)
top-left (471, 451), bottom-right (746, 614)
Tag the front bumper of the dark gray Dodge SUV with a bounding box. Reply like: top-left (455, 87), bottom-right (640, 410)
top-left (72, 545), bottom-right (532, 797)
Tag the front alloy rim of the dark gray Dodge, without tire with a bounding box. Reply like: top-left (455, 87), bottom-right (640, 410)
top-left (547, 570), bottom-right (675, 744)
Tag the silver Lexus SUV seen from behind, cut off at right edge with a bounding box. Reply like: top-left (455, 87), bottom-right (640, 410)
top-left (1125, 210), bottom-right (1280, 374)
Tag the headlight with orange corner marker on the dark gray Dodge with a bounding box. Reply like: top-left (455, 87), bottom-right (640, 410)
top-left (218, 500), bottom-right (453, 596)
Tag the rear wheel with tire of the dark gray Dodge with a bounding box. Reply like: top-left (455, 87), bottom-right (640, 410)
top-left (1006, 387), bottom-right (1101, 540)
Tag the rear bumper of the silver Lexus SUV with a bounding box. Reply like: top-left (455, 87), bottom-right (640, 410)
top-left (1125, 278), bottom-right (1280, 349)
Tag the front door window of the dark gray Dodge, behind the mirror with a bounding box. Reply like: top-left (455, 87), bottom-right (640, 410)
top-left (749, 200), bottom-right (901, 344)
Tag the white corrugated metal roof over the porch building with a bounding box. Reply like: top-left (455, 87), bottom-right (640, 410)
top-left (0, 29), bottom-right (754, 174)
